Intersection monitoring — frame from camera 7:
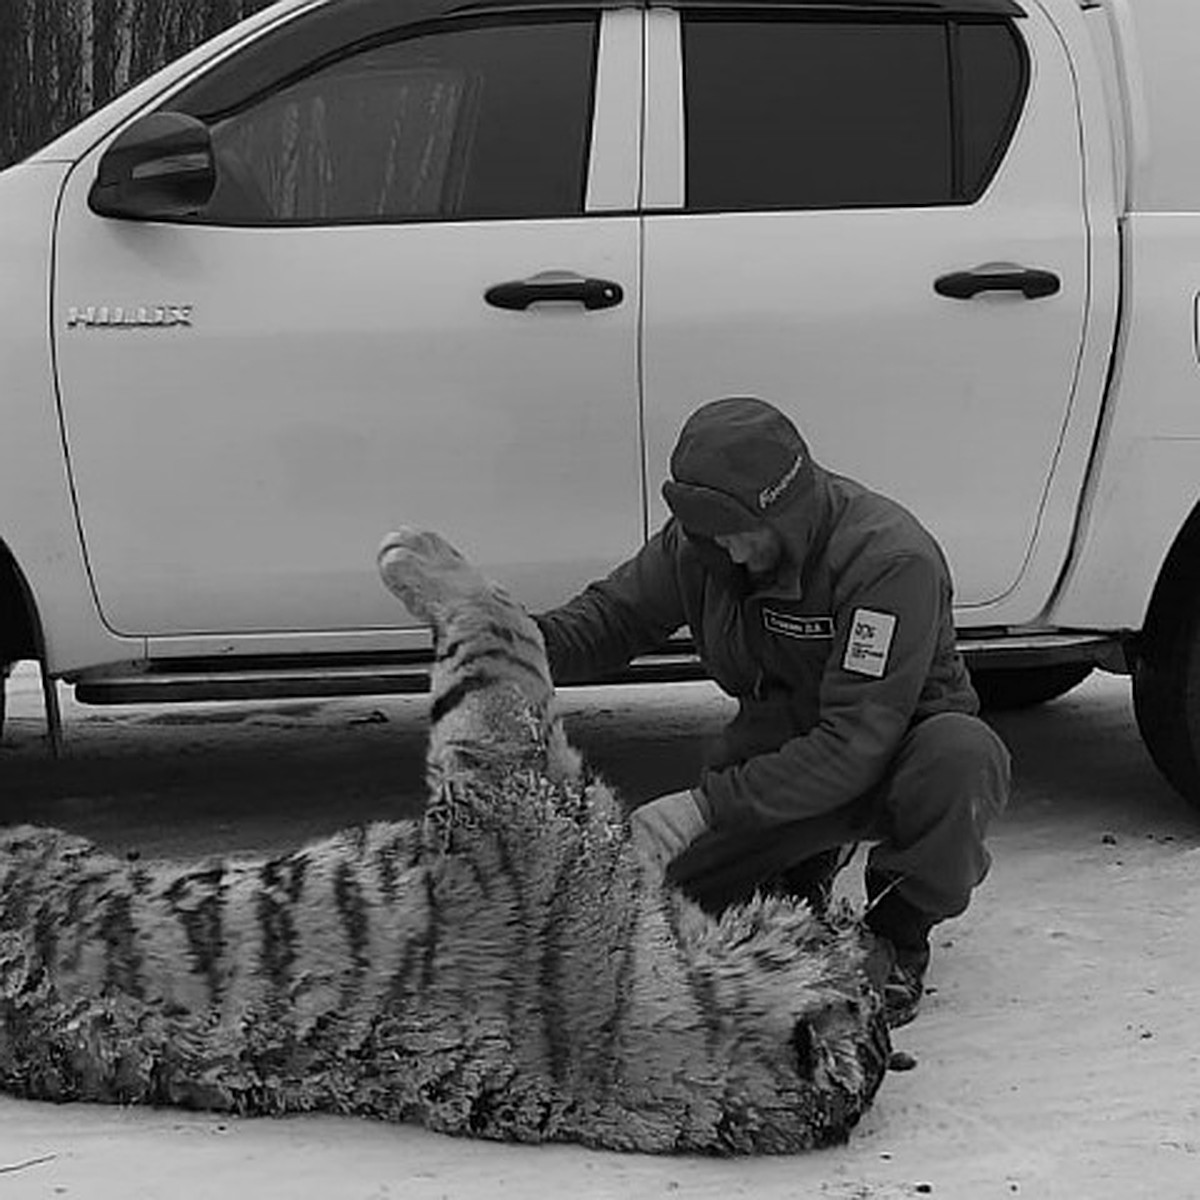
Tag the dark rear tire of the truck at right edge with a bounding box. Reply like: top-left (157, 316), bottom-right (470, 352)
top-left (1133, 612), bottom-right (1200, 806)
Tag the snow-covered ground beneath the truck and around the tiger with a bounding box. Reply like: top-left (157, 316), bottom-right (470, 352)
top-left (0, 668), bottom-right (1200, 1200)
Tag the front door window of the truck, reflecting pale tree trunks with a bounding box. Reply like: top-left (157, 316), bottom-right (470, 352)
top-left (170, 17), bottom-right (596, 224)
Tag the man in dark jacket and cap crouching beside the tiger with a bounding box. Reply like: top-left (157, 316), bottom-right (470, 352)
top-left (538, 397), bottom-right (1009, 1026)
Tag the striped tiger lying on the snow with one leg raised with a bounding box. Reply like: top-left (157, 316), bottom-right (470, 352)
top-left (0, 532), bottom-right (888, 1153)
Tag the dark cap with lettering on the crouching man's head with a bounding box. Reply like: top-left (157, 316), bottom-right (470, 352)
top-left (662, 396), bottom-right (814, 538)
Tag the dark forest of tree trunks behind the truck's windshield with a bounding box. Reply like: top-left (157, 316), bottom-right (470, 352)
top-left (0, 0), bottom-right (270, 168)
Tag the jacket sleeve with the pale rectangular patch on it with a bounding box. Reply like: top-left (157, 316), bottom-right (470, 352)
top-left (700, 556), bottom-right (948, 828)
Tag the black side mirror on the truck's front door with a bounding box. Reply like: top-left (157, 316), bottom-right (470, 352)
top-left (88, 113), bottom-right (217, 221)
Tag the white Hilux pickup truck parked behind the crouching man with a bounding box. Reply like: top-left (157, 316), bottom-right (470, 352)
top-left (0, 0), bottom-right (1200, 803)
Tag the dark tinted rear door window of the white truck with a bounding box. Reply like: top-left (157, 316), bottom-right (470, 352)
top-left (683, 12), bottom-right (1026, 211)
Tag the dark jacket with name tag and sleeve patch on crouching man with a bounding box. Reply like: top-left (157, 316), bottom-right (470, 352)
top-left (538, 464), bottom-right (978, 828)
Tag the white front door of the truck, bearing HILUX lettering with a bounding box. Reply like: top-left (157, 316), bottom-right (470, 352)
top-left (55, 0), bottom-right (642, 648)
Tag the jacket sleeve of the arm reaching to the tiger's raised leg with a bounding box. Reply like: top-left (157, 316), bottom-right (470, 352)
top-left (534, 521), bottom-right (686, 683)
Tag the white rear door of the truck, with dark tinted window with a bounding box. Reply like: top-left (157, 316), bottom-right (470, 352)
top-left (643, 0), bottom-right (1090, 623)
